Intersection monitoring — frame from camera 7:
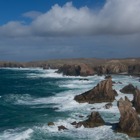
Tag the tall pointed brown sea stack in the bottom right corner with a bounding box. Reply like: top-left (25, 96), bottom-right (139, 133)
top-left (117, 97), bottom-right (140, 137)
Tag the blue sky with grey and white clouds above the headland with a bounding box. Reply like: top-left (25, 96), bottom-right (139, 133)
top-left (0, 0), bottom-right (140, 61)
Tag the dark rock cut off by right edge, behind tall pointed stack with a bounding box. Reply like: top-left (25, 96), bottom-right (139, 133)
top-left (133, 89), bottom-right (140, 113)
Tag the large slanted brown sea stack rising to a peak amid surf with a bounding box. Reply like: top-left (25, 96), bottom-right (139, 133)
top-left (74, 78), bottom-right (116, 104)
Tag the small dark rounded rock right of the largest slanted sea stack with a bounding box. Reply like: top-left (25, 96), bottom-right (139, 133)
top-left (120, 84), bottom-right (136, 94)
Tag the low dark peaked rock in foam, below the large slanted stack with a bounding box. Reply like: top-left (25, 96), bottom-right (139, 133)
top-left (76, 112), bottom-right (105, 128)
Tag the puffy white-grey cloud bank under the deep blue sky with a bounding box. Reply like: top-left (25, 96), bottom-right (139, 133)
top-left (0, 0), bottom-right (140, 37)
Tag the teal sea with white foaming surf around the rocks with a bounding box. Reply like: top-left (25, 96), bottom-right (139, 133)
top-left (0, 68), bottom-right (140, 140)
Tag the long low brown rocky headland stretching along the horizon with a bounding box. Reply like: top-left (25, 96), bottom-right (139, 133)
top-left (0, 58), bottom-right (140, 76)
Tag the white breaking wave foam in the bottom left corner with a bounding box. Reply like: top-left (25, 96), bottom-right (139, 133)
top-left (0, 129), bottom-right (33, 140)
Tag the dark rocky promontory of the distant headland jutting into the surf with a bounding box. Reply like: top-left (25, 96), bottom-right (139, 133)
top-left (57, 64), bottom-right (94, 76)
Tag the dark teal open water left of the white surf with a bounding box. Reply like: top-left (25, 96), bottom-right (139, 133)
top-left (0, 69), bottom-right (74, 139)
